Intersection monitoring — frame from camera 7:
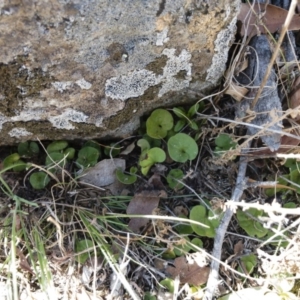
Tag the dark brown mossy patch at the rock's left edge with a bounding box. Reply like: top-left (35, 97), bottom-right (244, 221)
top-left (0, 56), bottom-right (53, 117)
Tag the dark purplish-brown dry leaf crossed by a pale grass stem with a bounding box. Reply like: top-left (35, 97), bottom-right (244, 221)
top-left (126, 190), bottom-right (159, 233)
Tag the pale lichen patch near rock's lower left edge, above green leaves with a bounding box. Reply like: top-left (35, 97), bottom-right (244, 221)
top-left (49, 108), bottom-right (88, 130)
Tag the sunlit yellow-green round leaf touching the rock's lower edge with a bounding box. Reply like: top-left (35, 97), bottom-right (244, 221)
top-left (146, 108), bottom-right (174, 139)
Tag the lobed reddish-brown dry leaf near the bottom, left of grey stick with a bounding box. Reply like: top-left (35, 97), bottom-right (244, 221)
top-left (166, 256), bottom-right (210, 286)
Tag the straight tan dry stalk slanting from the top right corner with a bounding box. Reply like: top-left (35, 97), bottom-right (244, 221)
top-left (251, 0), bottom-right (297, 109)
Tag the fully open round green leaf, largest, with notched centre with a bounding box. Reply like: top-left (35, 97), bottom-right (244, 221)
top-left (168, 133), bottom-right (198, 163)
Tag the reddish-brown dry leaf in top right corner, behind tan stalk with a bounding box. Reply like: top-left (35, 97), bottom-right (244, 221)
top-left (238, 3), bottom-right (300, 36)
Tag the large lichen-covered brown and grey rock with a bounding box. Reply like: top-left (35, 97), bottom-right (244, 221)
top-left (0, 0), bottom-right (240, 144)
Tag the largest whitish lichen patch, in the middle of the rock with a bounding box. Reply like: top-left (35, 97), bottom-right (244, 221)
top-left (105, 48), bottom-right (191, 101)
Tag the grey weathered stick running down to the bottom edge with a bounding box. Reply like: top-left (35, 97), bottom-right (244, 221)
top-left (204, 145), bottom-right (249, 300)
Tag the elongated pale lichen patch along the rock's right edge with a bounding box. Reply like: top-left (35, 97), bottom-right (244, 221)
top-left (206, 18), bottom-right (236, 84)
